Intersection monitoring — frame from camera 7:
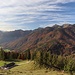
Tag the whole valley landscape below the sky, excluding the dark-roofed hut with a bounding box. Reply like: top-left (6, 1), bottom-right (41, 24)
top-left (0, 24), bottom-right (75, 75)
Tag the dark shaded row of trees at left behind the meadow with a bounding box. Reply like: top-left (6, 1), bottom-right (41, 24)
top-left (0, 48), bottom-right (31, 61)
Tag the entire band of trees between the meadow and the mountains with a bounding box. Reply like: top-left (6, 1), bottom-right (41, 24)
top-left (0, 48), bottom-right (75, 72)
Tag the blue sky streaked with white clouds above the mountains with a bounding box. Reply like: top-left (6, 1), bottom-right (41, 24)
top-left (0, 0), bottom-right (75, 31)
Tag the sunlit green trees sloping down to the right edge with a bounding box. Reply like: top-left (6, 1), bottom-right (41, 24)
top-left (35, 51), bottom-right (75, 72)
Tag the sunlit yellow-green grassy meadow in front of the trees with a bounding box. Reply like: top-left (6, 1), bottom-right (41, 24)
top-left (0, 61), bottom-right (69, 75)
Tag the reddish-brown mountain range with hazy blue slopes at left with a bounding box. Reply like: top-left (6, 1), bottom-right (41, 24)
top-left (0, 24), bottom-right (75, 55)
